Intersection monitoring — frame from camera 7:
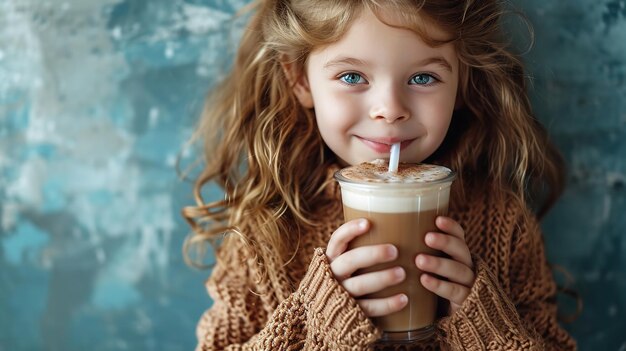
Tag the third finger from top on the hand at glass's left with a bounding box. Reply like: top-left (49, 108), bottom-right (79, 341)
top-left (341, 267), bottom-right (406, 297)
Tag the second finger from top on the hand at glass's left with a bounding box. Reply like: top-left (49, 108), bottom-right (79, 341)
top-left (330, 244), bottom-right (398, 281)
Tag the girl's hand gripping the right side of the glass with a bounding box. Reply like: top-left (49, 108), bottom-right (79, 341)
top-left (415, 216), bottom-right (476, 314)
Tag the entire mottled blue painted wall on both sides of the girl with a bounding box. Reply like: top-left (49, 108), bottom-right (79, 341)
top-left (0, 0), bottom-right (626, 351)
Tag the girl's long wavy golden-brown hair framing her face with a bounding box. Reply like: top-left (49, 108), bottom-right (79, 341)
top-left (183, 0), bottom-right (563, 288)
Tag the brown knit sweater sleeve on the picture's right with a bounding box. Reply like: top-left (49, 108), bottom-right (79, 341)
top-left (439, 210), bottom-right (576, 350)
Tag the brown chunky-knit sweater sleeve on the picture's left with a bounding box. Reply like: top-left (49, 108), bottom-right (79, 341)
top-left (196, 249), bottom-right (379, 350)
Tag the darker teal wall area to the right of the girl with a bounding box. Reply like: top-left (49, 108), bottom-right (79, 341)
top-left (517, 0), bottom-right (626, 350)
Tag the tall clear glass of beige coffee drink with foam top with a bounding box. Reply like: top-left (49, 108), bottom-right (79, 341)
top-left (335, 160), bottom-right (455, 341)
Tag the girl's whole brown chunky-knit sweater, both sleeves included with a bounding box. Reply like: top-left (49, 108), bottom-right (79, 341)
top-left (197, 169), bottom-right (576, 350)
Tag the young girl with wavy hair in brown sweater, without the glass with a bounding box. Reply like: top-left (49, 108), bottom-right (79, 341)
top-left (184, 0), bottom-right (576, 350)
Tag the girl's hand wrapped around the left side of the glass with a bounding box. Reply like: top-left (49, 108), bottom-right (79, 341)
top-left (326, 218), bottom-right (408, 317)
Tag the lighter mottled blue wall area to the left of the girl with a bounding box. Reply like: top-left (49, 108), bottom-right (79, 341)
top-left (0, 0), bottom-right (247, 351)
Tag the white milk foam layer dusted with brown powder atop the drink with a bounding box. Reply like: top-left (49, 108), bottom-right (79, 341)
top-left (338, 160), bottom-right (454, 213)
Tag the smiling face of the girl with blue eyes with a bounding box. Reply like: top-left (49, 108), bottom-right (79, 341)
top-left (294, 10), bottom-right (459, 165)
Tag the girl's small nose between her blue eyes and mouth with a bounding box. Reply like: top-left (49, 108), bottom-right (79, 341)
top-left (370, 85), bottom-right (411, 124)
